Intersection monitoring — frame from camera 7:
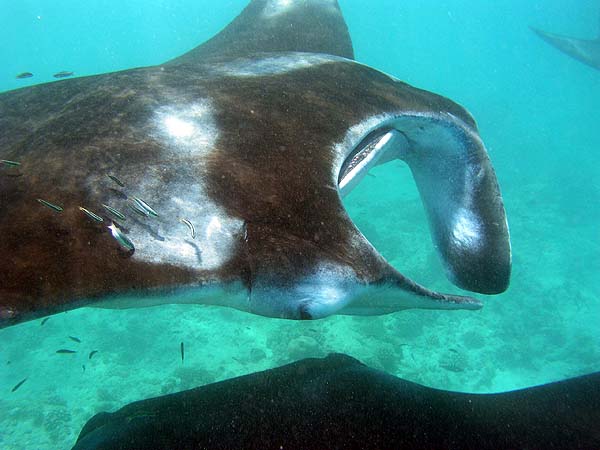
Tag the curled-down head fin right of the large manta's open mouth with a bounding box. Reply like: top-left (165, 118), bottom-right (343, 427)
top-left (394, 113), bottom-right (511, 294)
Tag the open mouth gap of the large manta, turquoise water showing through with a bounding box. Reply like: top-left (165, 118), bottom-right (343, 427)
top-left (338, 128), bottom-right (444, 284)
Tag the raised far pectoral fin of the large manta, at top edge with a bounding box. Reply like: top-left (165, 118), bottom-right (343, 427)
top-left (169, 0), bottom-right (354, 63)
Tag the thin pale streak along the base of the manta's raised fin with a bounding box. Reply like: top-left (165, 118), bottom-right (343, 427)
top-left (214, 52), bottom-right (349, 77)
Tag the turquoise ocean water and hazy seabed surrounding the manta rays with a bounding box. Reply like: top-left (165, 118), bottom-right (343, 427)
top-left (0, 0), bottom-right (600, 449)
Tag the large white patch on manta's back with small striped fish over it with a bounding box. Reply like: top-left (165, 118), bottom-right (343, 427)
top-left (110, 99), bottom-right (243, 270)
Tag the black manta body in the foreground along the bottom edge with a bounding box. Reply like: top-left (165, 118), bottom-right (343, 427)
top-left (74, 354), bottom-right (600, 450)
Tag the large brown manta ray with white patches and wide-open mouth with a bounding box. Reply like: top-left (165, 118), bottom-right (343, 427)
top-left (0, 0), bottom-right (511, 327)
